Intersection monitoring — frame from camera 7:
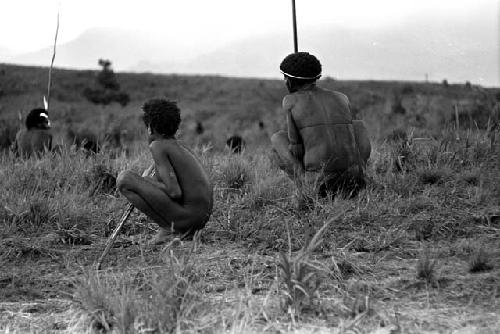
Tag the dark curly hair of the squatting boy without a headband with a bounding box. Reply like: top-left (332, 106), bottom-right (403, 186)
top-left (142, 98), bottom-right (181, 137)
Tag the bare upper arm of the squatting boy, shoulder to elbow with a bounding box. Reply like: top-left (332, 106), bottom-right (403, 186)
top-left (151, 142), bottom-right (182, 199)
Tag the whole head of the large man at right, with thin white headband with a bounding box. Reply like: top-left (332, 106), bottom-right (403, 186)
top-left (280, 52), bottom-right (321, 93)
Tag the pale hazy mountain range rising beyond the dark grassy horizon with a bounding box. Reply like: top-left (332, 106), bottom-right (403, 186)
top-left (0, 11), bottom-right (500, 86)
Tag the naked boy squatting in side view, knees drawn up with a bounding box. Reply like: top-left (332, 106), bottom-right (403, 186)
top-left (117, 99), bottom-right (213, 243)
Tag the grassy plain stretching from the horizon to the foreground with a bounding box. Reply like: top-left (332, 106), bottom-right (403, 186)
top-left (0, 66), bottom-right (500, 333)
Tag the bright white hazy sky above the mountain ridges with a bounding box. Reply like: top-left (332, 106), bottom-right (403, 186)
top-left (0, 0), bottom-right (500, 52)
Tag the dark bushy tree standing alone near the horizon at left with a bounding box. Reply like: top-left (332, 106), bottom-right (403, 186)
top-left (83, 59), bottom-right (130, 107)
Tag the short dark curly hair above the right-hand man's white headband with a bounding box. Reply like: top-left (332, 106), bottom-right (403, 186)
top-left (280, 52), bottom-right (321, 80)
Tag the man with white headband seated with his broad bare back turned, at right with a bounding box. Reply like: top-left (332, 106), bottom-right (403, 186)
top-left (271, 52), bottom-right (371, 197)
